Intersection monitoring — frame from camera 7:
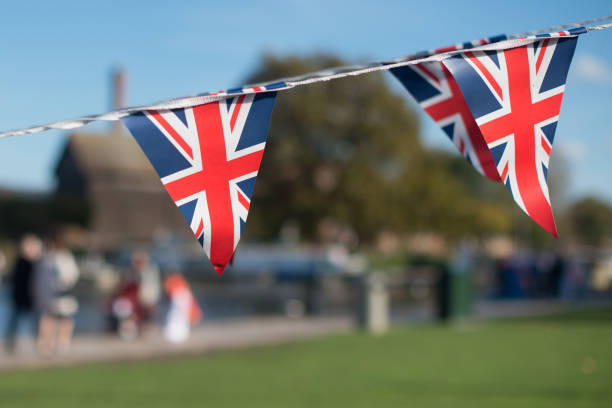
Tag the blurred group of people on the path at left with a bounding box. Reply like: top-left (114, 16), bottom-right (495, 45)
top-left (0, 234), bottom-right (202, 356)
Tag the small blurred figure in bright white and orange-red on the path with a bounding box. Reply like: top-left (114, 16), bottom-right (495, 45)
top-left (164, 273), bottom-right (202, 343)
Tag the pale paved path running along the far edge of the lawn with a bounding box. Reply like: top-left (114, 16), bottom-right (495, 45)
top-left (0, 300), bottom-right (610, 371)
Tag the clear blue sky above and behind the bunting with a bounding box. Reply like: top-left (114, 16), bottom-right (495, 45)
top-left (0, 0), bottom-right (612, 201)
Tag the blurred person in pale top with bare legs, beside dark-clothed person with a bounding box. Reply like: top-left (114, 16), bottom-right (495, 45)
top-left (35, 236), bottom-right (79, 355)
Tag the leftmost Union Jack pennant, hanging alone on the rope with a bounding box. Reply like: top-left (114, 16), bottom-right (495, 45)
top-left (122, 92), bottom-right (276, 275)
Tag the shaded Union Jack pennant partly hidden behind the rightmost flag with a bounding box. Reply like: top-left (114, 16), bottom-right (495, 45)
top-left (391, 61), bottom-right (499, 181)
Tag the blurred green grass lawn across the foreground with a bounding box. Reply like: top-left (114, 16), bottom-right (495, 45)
top-left (0, 310), bottom-right (612, 408)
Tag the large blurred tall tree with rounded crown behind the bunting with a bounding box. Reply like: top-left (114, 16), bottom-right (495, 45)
top-left (247, 56), bottom-right (422, 244)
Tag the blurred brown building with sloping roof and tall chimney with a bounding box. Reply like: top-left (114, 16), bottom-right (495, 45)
top-left (55, 73), bottom-right (190, 249)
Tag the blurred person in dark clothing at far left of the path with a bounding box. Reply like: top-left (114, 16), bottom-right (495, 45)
top-left (5, 234), bottom-right (42, 354)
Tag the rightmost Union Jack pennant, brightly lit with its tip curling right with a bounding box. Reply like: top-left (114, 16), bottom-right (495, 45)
top-left (444, 33), bottom-right (576, 237)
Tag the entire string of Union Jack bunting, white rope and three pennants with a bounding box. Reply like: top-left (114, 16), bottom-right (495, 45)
top-left (0, 16), bottom-right (612, 275)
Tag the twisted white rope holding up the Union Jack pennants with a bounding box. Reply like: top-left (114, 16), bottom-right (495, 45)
top-left (0, 16), bottom-right (612, 139)
